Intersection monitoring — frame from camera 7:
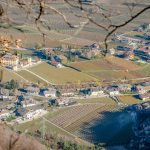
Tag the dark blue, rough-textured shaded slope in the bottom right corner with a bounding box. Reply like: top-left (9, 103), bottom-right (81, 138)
top-left (129, 102), bottom-right (150, 150)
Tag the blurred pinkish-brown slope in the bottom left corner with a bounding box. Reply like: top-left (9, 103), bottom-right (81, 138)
top-left (0, 124), bottom-right (46, 150)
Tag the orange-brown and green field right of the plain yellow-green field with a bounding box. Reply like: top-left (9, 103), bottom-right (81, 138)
top-left (70, 57), bottom-right (146, 81)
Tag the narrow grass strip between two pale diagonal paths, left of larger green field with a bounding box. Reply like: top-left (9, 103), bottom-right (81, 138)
top-left (17, 70), bottom-right (46, 84)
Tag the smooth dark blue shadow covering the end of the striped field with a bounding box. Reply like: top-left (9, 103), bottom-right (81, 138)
top-left (79, 110), bottom-right (133, 145)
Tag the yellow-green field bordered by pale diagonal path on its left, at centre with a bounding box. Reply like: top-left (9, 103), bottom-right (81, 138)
top-left (29, 63), bottom-right (96, 84)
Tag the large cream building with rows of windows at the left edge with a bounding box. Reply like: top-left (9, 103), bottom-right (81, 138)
top-left (0, 53), bottom-right (19, 66)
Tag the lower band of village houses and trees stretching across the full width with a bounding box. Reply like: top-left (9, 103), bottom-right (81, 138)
top-left (0, 75), bottom-right (150, 123)
